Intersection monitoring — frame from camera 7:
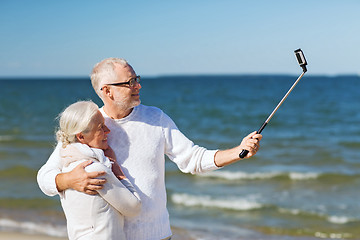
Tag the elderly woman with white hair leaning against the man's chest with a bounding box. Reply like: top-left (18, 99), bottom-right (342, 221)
top-left (56, 101), bottom-right (141, 240)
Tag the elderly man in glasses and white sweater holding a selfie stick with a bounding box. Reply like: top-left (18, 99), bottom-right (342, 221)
top-left (38, 58), bottom-right (262, 240)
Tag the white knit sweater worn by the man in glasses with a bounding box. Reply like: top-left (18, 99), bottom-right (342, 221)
top-left (38, 105), bottom-right (218, 240)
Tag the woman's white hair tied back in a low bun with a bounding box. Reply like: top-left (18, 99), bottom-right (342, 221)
top-left (56, 101), bottom-right (99, 147)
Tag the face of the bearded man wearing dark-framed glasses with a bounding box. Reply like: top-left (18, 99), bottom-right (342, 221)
top-left (109, 64), bottom-right (141, 109)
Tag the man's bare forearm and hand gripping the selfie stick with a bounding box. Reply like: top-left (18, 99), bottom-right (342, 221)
top-left (214, 131), bottom-right (262, 167)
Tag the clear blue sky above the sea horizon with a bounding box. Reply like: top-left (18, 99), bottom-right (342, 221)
top-left (0, 0), bottom-right (360, 78)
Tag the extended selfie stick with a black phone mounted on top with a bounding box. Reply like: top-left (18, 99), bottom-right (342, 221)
top-left (239, 48), bottom-right (307, 158)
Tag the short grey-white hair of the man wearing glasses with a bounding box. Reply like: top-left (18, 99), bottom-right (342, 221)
top-left (90, 58), bottom-right (129, 98)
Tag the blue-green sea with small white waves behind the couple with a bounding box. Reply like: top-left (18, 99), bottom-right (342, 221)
top-left (0, 74), bottom-right (360, 240)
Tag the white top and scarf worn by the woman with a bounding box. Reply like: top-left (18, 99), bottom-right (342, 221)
top-left (60, 143), bottom-right (141, 240)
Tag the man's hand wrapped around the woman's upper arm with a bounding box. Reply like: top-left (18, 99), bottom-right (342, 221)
top-left (55, 160), bottom-right (106, 195)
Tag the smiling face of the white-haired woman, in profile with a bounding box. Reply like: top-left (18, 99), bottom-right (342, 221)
top-left (78, 111), bottom-right (110, 150)
